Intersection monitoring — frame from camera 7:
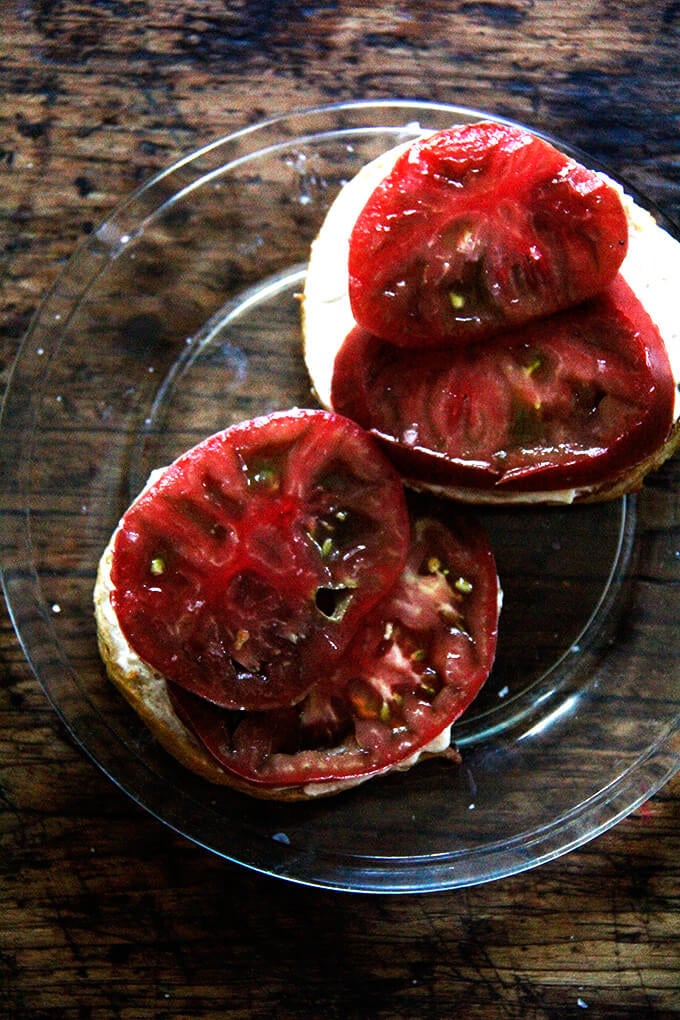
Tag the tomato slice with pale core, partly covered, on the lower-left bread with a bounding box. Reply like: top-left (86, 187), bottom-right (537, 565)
top-left (168, 517), bottom-right (499, 786)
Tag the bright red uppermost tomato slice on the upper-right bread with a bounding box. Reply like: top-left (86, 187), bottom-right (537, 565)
top-left (349, 122), bottom-right (628, 347)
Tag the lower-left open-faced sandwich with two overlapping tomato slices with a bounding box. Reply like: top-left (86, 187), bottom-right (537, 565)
top-left (95, 410), bottom-right (500, 800)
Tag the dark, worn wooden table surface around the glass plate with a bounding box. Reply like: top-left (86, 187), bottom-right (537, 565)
top-left (0, 0), bottom-right (680, 1020)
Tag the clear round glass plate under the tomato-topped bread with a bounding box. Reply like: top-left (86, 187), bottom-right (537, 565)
top-left (0, 102), bottom-right (680, 893)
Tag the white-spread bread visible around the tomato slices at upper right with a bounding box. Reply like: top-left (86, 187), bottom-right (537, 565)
top-left (302, 133), bottom-right (680, 505)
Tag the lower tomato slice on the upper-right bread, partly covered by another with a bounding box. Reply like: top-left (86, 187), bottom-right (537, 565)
top-left (332, 275), bottom-right (674, 492)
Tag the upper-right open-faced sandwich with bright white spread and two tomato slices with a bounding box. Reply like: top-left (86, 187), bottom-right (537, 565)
top-left (303, 121), bottom-right (680, 503)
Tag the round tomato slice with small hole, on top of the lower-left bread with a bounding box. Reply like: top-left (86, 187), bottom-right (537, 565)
top-left (111, 410), bottom-right (409, 708)
